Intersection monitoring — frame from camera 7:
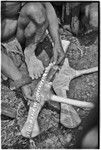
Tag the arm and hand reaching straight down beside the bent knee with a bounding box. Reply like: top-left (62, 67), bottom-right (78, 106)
top-left (44, 2), bottom-right (64, 64)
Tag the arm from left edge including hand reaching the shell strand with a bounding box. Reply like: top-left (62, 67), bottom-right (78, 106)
top-left (1, 51), bottom-right (33, 100)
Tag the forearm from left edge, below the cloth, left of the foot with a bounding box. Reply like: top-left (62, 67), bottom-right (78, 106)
top-left (1, 52), bottom-right (32, 90)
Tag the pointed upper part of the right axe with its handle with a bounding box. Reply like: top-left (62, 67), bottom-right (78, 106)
top-left (53, 58), bottom-right (98, 91)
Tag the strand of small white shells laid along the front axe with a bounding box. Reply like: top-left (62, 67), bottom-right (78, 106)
top-left (21, 63), bottom-right (54, 138)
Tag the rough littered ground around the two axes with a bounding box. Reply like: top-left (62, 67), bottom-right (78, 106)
top-left (1, 30), bottom-right (98, 149)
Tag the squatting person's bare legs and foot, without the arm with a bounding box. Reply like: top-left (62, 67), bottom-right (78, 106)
top-left (2, 2), bottom-right (48, 82)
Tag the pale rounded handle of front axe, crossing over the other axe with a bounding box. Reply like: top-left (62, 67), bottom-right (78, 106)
top-left (50, 95), bottom-right (94, 108)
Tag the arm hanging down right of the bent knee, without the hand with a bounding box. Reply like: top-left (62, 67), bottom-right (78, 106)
top-left (45, 3), bottom-right (61, 45)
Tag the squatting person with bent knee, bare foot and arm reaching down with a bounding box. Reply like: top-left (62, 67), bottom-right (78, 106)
top-left (17, 2), bottom-right (64, 79)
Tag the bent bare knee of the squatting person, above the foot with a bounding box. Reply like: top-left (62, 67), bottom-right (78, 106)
top-left (17, 2), bottom-right (48, 45)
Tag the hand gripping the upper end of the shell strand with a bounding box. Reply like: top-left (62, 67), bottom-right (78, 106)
top-left (53, 45), bottom-right (64, 64)
